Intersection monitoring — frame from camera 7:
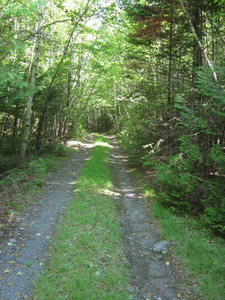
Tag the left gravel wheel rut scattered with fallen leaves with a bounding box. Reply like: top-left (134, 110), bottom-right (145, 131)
top-left (0, 136), bottom-right (93, 300)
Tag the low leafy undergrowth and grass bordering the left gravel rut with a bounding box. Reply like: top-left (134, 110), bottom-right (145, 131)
top-left (0, 148), bottom-right (74, 237)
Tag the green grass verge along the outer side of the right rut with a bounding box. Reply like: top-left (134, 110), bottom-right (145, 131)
top-left (137, 169), bottom-right (225, 300)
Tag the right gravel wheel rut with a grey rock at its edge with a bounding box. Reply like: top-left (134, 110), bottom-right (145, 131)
top-left (110, 139), bottom-right (190, 300)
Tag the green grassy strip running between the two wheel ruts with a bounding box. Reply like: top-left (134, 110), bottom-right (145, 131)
top-left (32, 136), bottom-right (129, 300)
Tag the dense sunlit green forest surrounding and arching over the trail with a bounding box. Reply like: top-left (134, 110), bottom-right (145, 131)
top-left (0, 0), bottom-right (225, 235)
